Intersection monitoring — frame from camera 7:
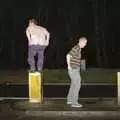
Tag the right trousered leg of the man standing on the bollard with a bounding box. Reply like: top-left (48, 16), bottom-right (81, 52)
top-left (37, 46), bottom-right (45, 72)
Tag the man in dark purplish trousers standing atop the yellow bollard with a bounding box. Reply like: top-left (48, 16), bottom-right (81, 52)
top-left (26, 19), bottom-right (50, 72)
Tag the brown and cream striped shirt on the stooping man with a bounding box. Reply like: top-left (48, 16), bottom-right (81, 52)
top-left (69, 45), bottom-right (81, 69)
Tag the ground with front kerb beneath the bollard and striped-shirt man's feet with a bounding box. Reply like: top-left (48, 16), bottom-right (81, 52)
top-left (1, 98), bottom-right (120, 118)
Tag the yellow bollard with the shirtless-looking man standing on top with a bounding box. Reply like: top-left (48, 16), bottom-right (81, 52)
top-left (29, 72), bottom-right (43, 103)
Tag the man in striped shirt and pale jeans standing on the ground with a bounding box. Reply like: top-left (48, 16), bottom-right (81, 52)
top-left (66, 37), bottom-right (87, 107)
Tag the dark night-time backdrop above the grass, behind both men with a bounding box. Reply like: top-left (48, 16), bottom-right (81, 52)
top-left (0, 0), bottom-right (120, 69)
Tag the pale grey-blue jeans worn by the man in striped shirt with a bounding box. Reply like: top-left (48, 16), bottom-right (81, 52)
top-left (67, 68), bottom-right (81, 104)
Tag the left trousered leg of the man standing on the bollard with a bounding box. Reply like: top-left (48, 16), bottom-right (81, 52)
top-left (28, 46), bottom-right (36, 72)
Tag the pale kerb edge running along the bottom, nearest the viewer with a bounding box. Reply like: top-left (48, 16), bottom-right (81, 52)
top-left (25, 111), bottom-right (120, 118)
